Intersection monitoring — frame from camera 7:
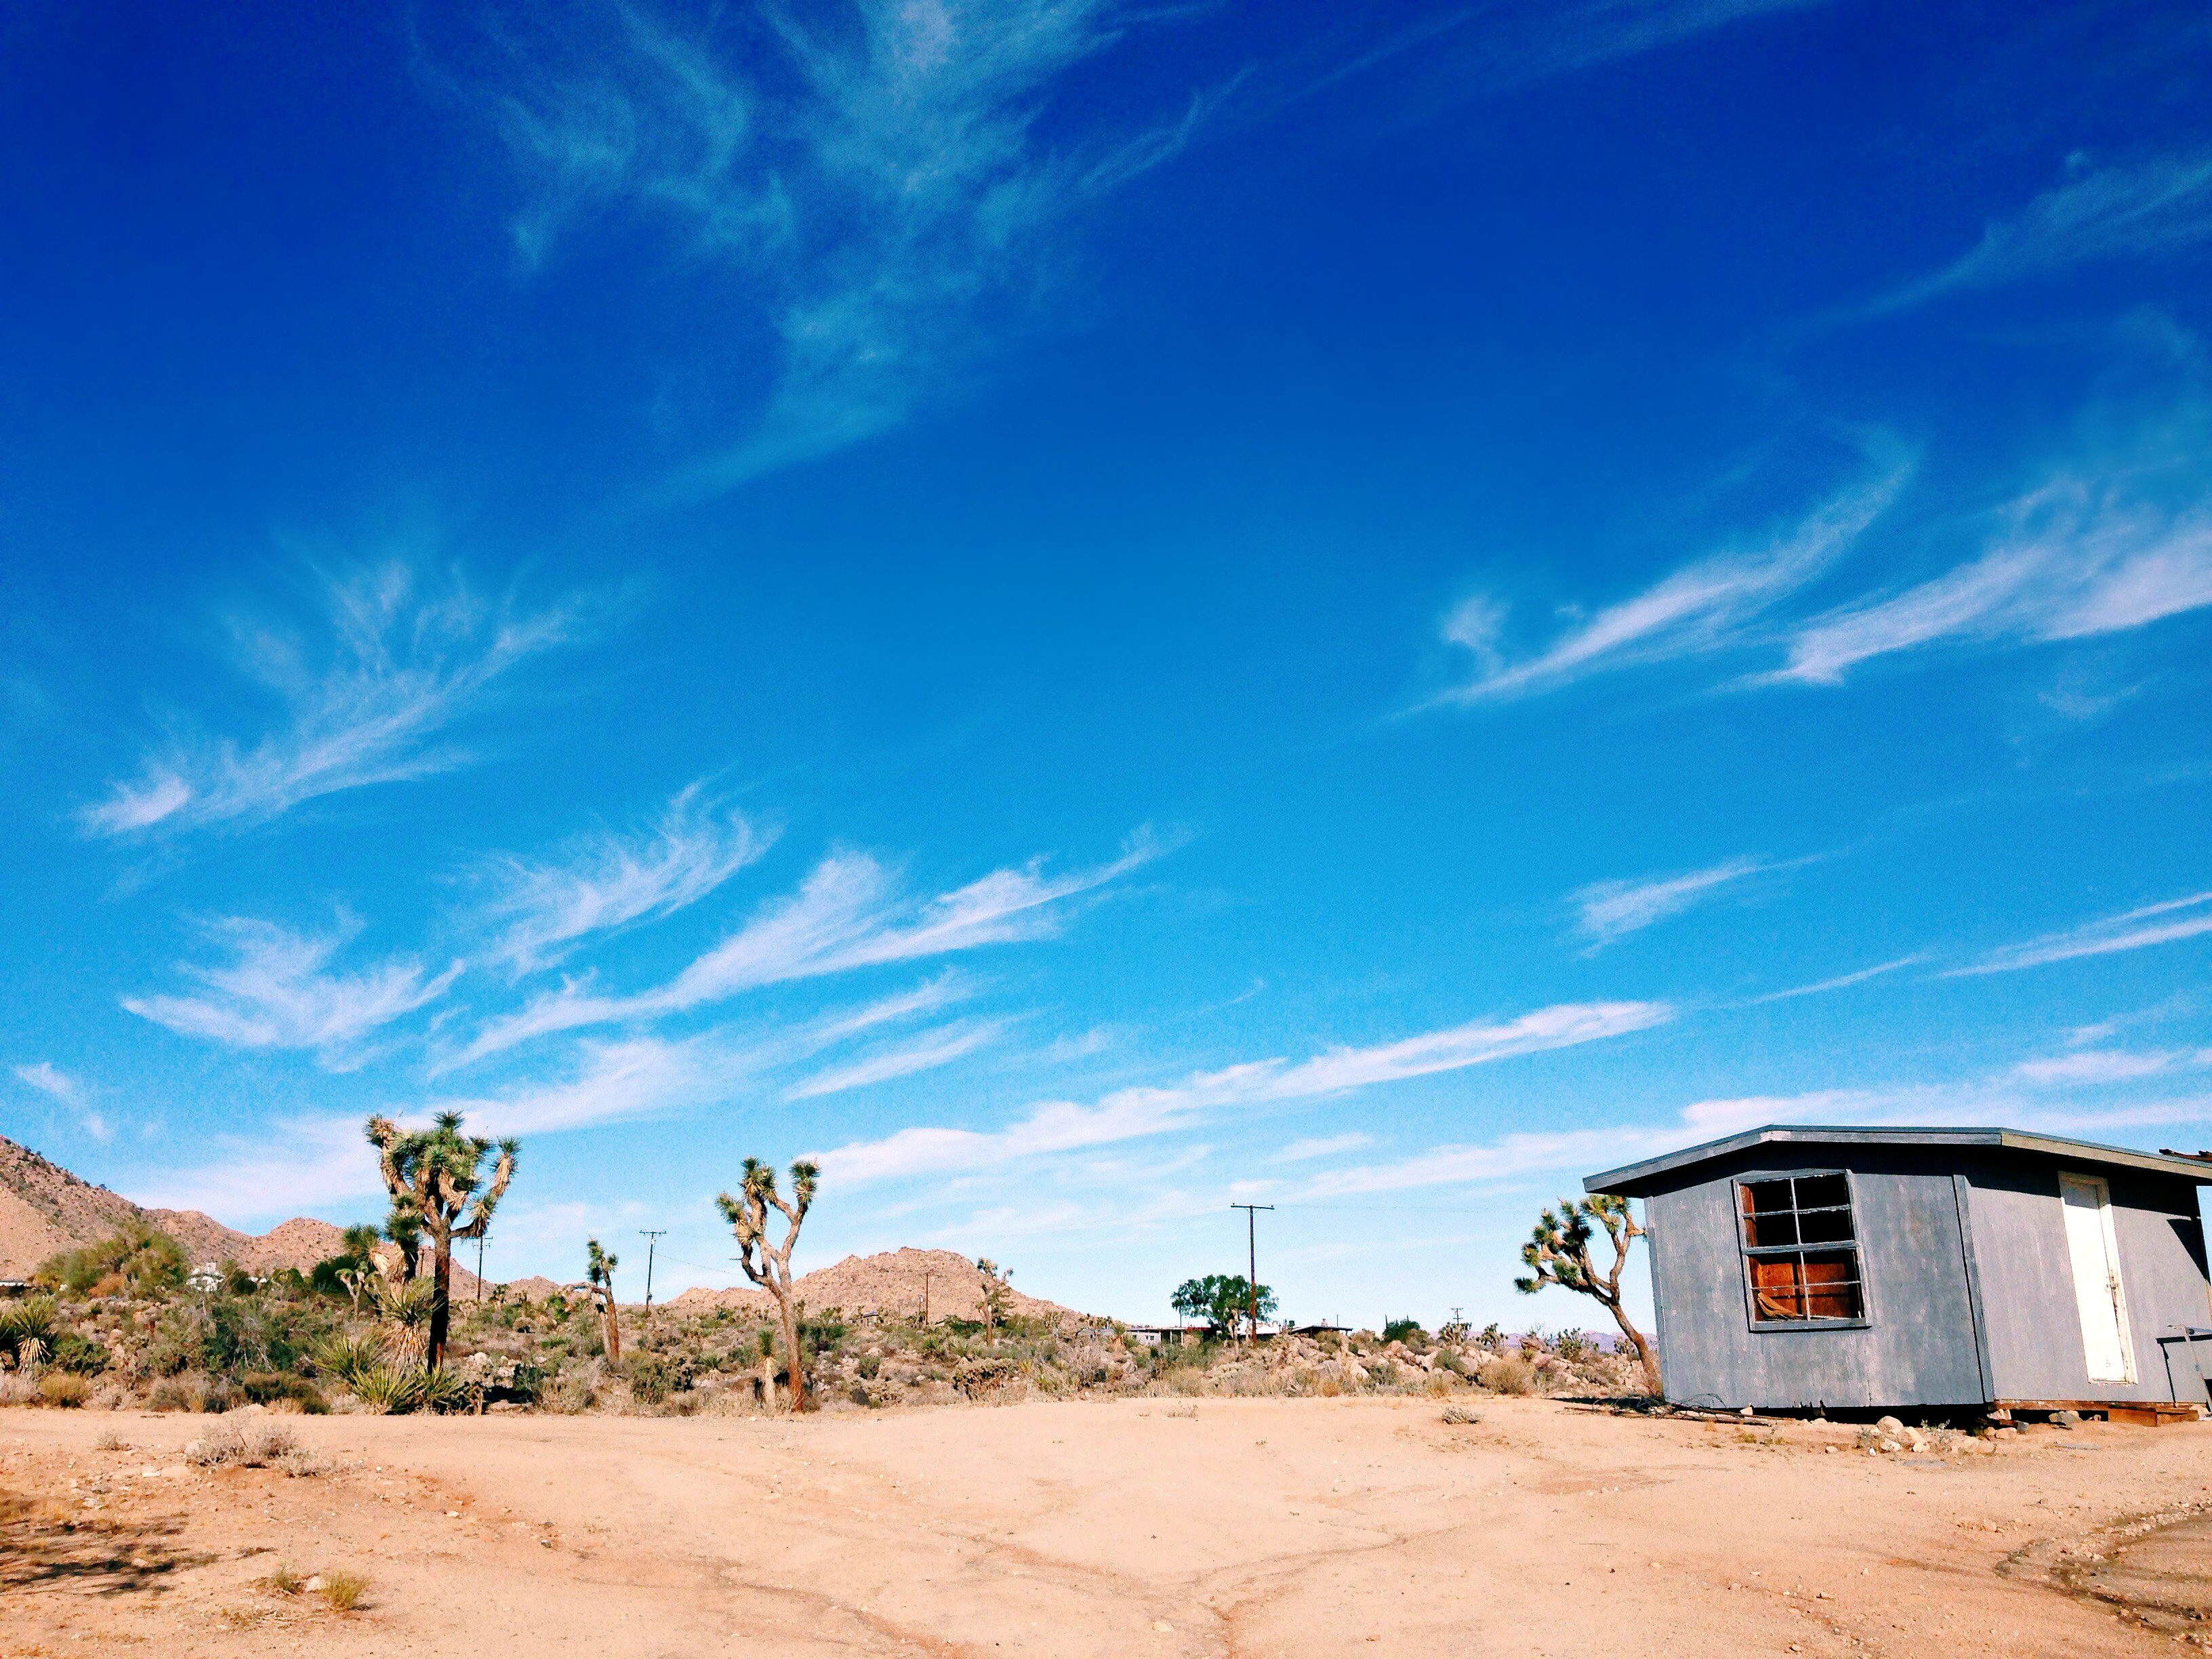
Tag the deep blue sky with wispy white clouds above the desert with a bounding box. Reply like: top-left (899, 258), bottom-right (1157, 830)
top-left (0, 0), bottom-right (2212, 1325)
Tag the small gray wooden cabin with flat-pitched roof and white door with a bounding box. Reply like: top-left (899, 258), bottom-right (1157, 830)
top-left (1584, 1126), bottom-right (2212, 1409)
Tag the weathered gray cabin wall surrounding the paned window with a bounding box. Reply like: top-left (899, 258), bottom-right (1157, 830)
top-left (1645, 1146), bottom-right (1990, 1409)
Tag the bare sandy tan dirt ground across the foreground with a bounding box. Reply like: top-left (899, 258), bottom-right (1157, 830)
top-left (0, 1400), bottom-right (2212, 1659)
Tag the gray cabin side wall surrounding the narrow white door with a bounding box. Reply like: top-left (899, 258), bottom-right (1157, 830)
top-left (1964, 1155), bottom-right (2212, 1405)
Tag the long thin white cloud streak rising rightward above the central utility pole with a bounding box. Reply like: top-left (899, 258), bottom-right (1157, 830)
top-left (821, 1002), bottom-right (1673, 1183)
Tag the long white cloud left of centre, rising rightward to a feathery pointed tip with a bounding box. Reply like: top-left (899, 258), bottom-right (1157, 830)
top-left (453, 834), bottom-right (1162, 1064)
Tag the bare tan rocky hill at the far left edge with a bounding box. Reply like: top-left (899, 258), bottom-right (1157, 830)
top-left (0, 1134), bottom-right (338, 1279)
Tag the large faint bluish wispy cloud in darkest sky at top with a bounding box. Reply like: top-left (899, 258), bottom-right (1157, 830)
top-left (495, 0), bottom-right (1218, 493)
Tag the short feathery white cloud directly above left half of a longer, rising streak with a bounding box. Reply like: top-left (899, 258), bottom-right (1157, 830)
top-left (485, 783), bottom-right (777, 971)
